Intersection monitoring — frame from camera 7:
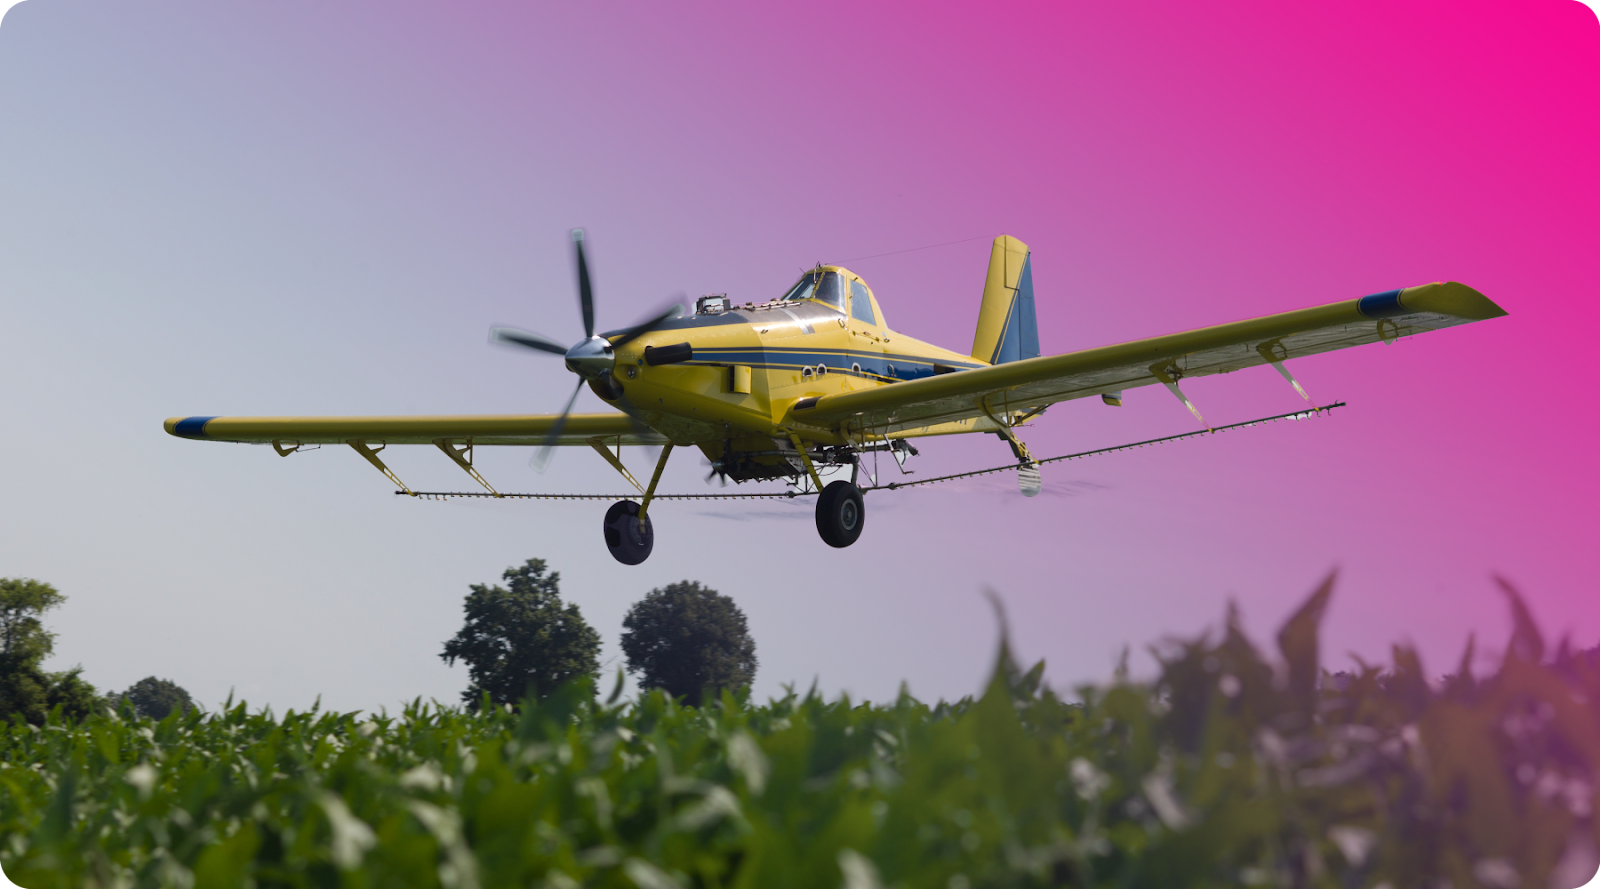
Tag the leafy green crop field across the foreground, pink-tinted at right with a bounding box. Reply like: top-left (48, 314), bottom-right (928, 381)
top-left (0, 575), bottom-right (1600, 889)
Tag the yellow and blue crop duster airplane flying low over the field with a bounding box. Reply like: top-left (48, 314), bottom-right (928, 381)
top-left (165, 229), bottom-right (1506, 564)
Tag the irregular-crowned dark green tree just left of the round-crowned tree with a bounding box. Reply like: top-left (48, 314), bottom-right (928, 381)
top-left (440, 558), bottom-right (600, 708)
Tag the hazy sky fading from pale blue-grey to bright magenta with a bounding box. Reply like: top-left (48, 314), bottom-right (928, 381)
top-left (0, 0), bottom-right (1600, 710)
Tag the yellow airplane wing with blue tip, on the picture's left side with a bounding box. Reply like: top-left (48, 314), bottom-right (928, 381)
top-left (165, 414), bottom-right (667, 449)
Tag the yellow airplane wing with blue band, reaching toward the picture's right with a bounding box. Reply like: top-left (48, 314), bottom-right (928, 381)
top-left (784, 281), bottom-right (1506, 437)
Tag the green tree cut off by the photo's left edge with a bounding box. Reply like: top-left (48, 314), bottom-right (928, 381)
top-left (0, 577), bottom-right (99, 724)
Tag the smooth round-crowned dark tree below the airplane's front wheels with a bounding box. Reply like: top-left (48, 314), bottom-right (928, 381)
top-left (622, 580), bottom-right (757, 704)
